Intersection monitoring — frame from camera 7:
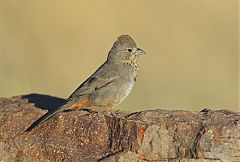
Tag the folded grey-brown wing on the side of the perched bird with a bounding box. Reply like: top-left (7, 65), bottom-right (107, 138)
top-left (69, 65), bottom-right (119, 99)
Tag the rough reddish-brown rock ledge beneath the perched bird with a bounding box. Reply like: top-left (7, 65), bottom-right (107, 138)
top-left (0, 94), bottom-right (240, 162)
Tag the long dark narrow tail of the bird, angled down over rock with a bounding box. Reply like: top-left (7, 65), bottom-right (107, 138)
top-left (24, 105), bottom-right (66, 132)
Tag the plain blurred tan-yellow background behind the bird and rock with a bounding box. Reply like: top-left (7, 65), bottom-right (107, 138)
top-left (0, 0), bottom-right (239, 111)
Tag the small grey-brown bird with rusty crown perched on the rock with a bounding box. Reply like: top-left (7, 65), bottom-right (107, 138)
top-left (25, 35), bottom-right (145, 132)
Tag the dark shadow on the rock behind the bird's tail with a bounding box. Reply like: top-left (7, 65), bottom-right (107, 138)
top-left (22, 93), bottom-right (67, 111)
